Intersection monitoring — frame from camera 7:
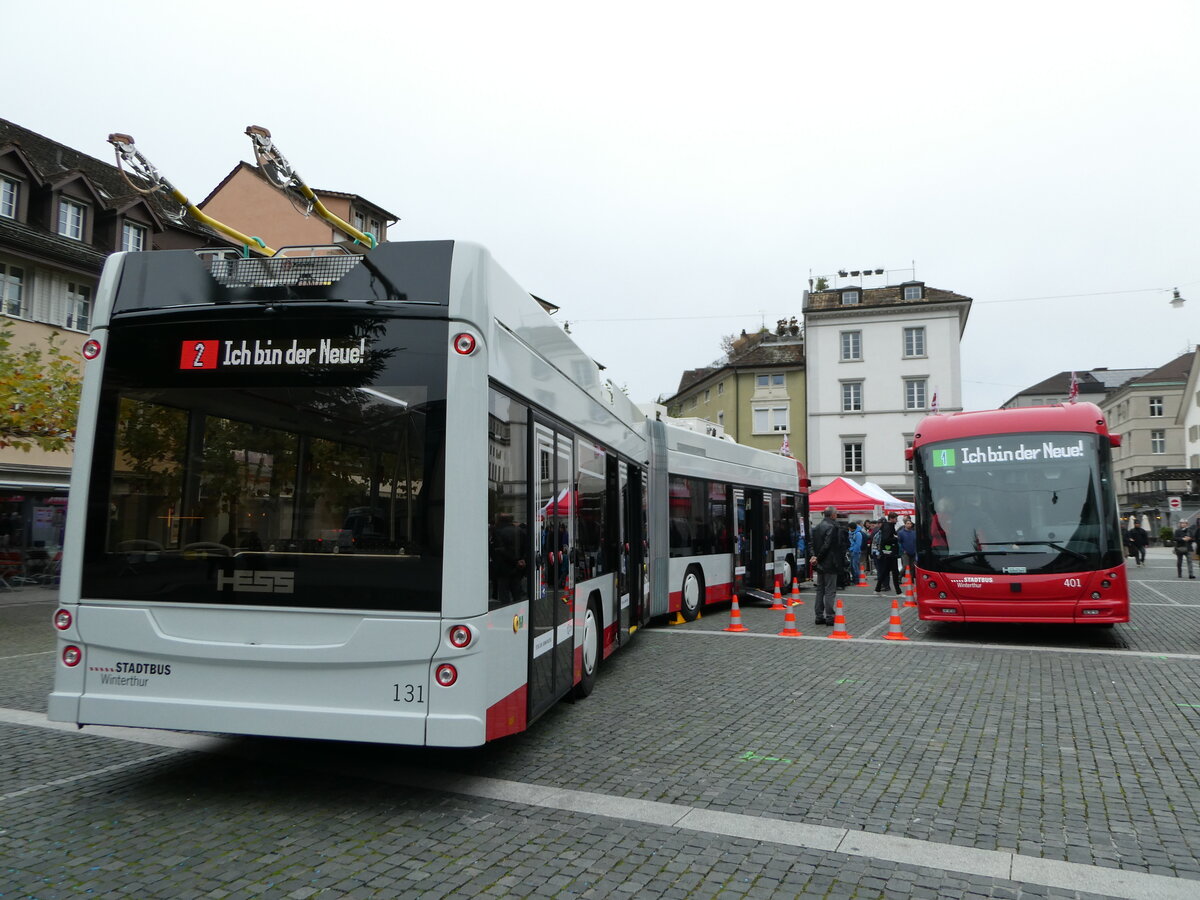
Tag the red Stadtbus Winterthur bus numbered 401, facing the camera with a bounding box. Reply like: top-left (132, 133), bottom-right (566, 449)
top-left (911, 403), bottom-right (1129, 625)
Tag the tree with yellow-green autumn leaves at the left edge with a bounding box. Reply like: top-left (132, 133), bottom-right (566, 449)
top-left (0, 323), bottom-right (83, 452)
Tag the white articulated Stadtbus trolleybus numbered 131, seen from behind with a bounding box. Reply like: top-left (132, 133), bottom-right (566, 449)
top-left (49, 133), bottom-right (806, 746)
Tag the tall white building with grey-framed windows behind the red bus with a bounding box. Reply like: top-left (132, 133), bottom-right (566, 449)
top-left (804, 281), bottom-right (972, 498)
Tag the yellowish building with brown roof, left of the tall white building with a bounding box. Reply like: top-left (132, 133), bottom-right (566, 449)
top-left (664, 320), bottom-right (806, 461)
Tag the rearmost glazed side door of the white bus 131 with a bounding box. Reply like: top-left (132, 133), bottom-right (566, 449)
top-left (529, 422), bottom-right (577, 721)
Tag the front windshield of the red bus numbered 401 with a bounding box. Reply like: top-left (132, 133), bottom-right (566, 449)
top-left (917, 432), bottom-right (1120, 575)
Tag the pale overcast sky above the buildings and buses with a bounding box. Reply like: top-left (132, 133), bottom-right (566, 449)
top-left (0, 0), bottom-right (1200, 409)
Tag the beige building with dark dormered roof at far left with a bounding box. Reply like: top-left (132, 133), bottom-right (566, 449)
top-left (0, 119), bottom-right (238, 550)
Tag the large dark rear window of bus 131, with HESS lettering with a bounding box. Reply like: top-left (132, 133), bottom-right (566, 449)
top-left (83, 320), bottom-right (445, 611)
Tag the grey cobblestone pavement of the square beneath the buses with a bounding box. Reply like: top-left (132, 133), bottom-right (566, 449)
top-left (0, 551), bottom-right (1200, 900)
